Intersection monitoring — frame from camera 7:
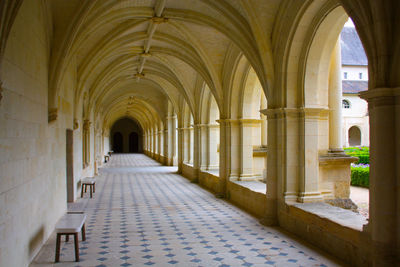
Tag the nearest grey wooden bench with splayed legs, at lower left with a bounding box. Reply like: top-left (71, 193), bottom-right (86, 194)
top-left (55, 213), bottom-right (86, 262)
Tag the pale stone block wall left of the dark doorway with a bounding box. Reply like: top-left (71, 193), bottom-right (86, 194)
top-left (0, 0), bottom-right (70, 266)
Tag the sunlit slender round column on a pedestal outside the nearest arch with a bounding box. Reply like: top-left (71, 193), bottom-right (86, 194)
top-left (329, 39), bottom-right (343, 154)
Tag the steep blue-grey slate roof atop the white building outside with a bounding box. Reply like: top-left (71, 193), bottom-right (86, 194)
top-left (340, 27), bottom-right (368, 66)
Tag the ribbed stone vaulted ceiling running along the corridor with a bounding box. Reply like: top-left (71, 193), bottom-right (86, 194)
top-left (49, 0), bottom-right (279, 130)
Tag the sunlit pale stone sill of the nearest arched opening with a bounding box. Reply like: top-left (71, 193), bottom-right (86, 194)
top-left (291, 202), bottom-right (368, 232)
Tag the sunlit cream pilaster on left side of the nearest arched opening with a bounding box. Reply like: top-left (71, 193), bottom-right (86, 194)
top-left (297, 108), bottom-right (324, 202)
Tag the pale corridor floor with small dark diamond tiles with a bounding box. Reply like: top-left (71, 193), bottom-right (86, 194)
top-left (31, 154), bottom-right (340, 267)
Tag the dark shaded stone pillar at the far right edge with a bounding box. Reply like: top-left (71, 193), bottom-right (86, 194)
top-left (361, 87), bottom-right (400, 266)
